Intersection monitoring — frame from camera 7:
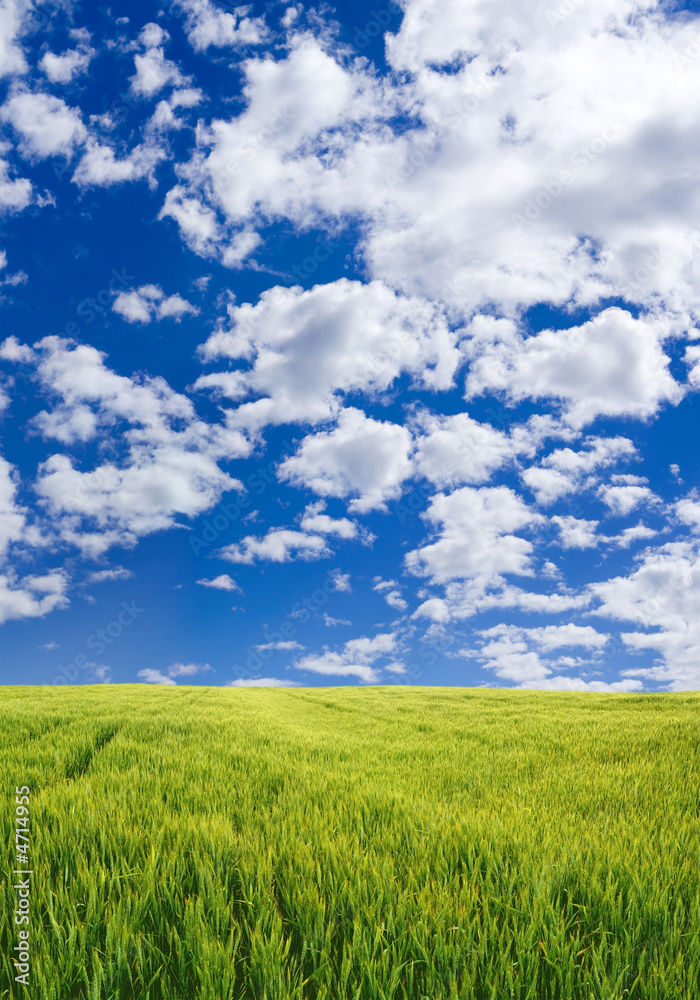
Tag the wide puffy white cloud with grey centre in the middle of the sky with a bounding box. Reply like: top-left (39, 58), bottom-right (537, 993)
top-left (196, 278), bottom-right (460, 430)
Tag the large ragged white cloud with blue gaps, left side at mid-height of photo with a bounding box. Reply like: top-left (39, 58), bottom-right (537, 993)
top-left (33, 337), bottom-right (249, 555)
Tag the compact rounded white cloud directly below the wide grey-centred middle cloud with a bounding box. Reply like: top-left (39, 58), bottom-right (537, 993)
top-left (277, 407), bottom-right (412, 513)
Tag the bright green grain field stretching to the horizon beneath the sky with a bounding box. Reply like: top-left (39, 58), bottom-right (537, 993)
top-left (0, 685), bottom-right (700, 1000)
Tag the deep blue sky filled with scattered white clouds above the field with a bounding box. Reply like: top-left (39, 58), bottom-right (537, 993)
top-left (0, 0), bottom-right (700, 692)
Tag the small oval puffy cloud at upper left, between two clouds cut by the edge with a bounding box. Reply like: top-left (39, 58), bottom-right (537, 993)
top-left (0, 92), bottom-right (87, 160)
